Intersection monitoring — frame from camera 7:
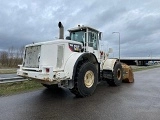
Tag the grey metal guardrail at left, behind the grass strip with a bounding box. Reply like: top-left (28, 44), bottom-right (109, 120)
top-left (0, 77), bottom-right (28, 84)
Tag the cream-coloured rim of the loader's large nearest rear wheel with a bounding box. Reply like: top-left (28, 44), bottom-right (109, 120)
top-left (84, 70), bottom-right (94, 88)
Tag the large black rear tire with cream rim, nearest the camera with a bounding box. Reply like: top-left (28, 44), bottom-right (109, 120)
top-left (71, 62), bottom-right (98, 97)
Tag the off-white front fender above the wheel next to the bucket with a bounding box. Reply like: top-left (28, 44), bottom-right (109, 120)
top-left (102, 59), bottom-right (117, 72)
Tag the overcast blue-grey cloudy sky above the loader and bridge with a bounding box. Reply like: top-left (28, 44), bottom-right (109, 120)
top-left (0, 0), bottom-right (160, 57)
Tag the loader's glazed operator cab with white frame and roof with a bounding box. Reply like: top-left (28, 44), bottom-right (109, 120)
top-left (66, 25), bottom-right (101, 58)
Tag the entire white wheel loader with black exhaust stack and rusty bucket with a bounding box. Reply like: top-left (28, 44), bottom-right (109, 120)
top-left (17, 22), bottom-right (134, 97)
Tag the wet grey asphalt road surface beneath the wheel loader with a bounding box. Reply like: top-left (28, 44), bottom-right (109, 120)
top-left (0, 68), bottom-right (160, 120)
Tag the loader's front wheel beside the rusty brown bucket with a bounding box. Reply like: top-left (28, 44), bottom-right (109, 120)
top-left (107, 62), bottom-right (123, 86)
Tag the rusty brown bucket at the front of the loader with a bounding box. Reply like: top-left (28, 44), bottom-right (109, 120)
top-left (122, 63), bottom-right (134, 83)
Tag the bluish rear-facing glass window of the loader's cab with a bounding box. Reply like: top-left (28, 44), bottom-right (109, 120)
top-left (71, 31), bottom-right (85, 42)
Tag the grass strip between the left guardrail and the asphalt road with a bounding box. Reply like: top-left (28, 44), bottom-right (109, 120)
top-left (0, 81), bottom-right (42, 96)
